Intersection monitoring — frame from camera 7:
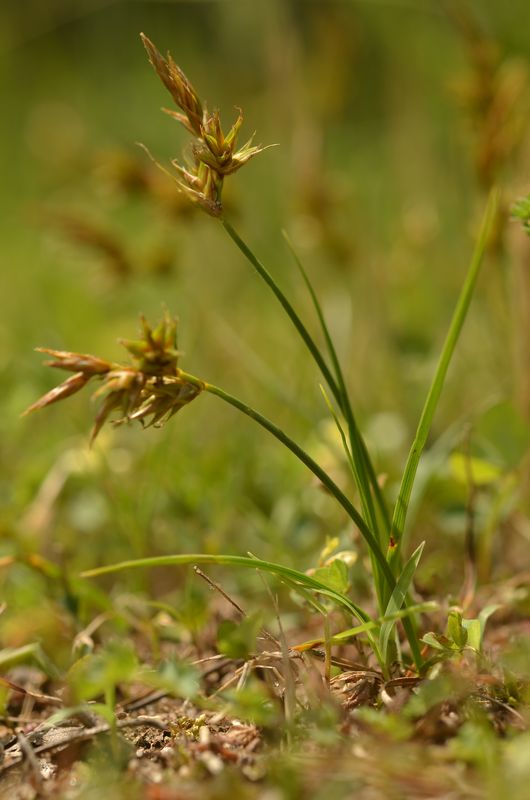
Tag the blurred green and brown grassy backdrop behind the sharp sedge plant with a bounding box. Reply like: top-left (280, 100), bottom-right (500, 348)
top-left (0, 0), bottom-right (530, 635)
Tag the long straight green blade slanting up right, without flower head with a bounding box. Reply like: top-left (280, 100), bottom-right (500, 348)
top-left (387, 192), bottom-right (497, 565)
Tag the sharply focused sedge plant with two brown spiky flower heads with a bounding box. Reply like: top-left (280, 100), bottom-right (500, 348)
top-left (22, 34), bottom-right (496, 676)
